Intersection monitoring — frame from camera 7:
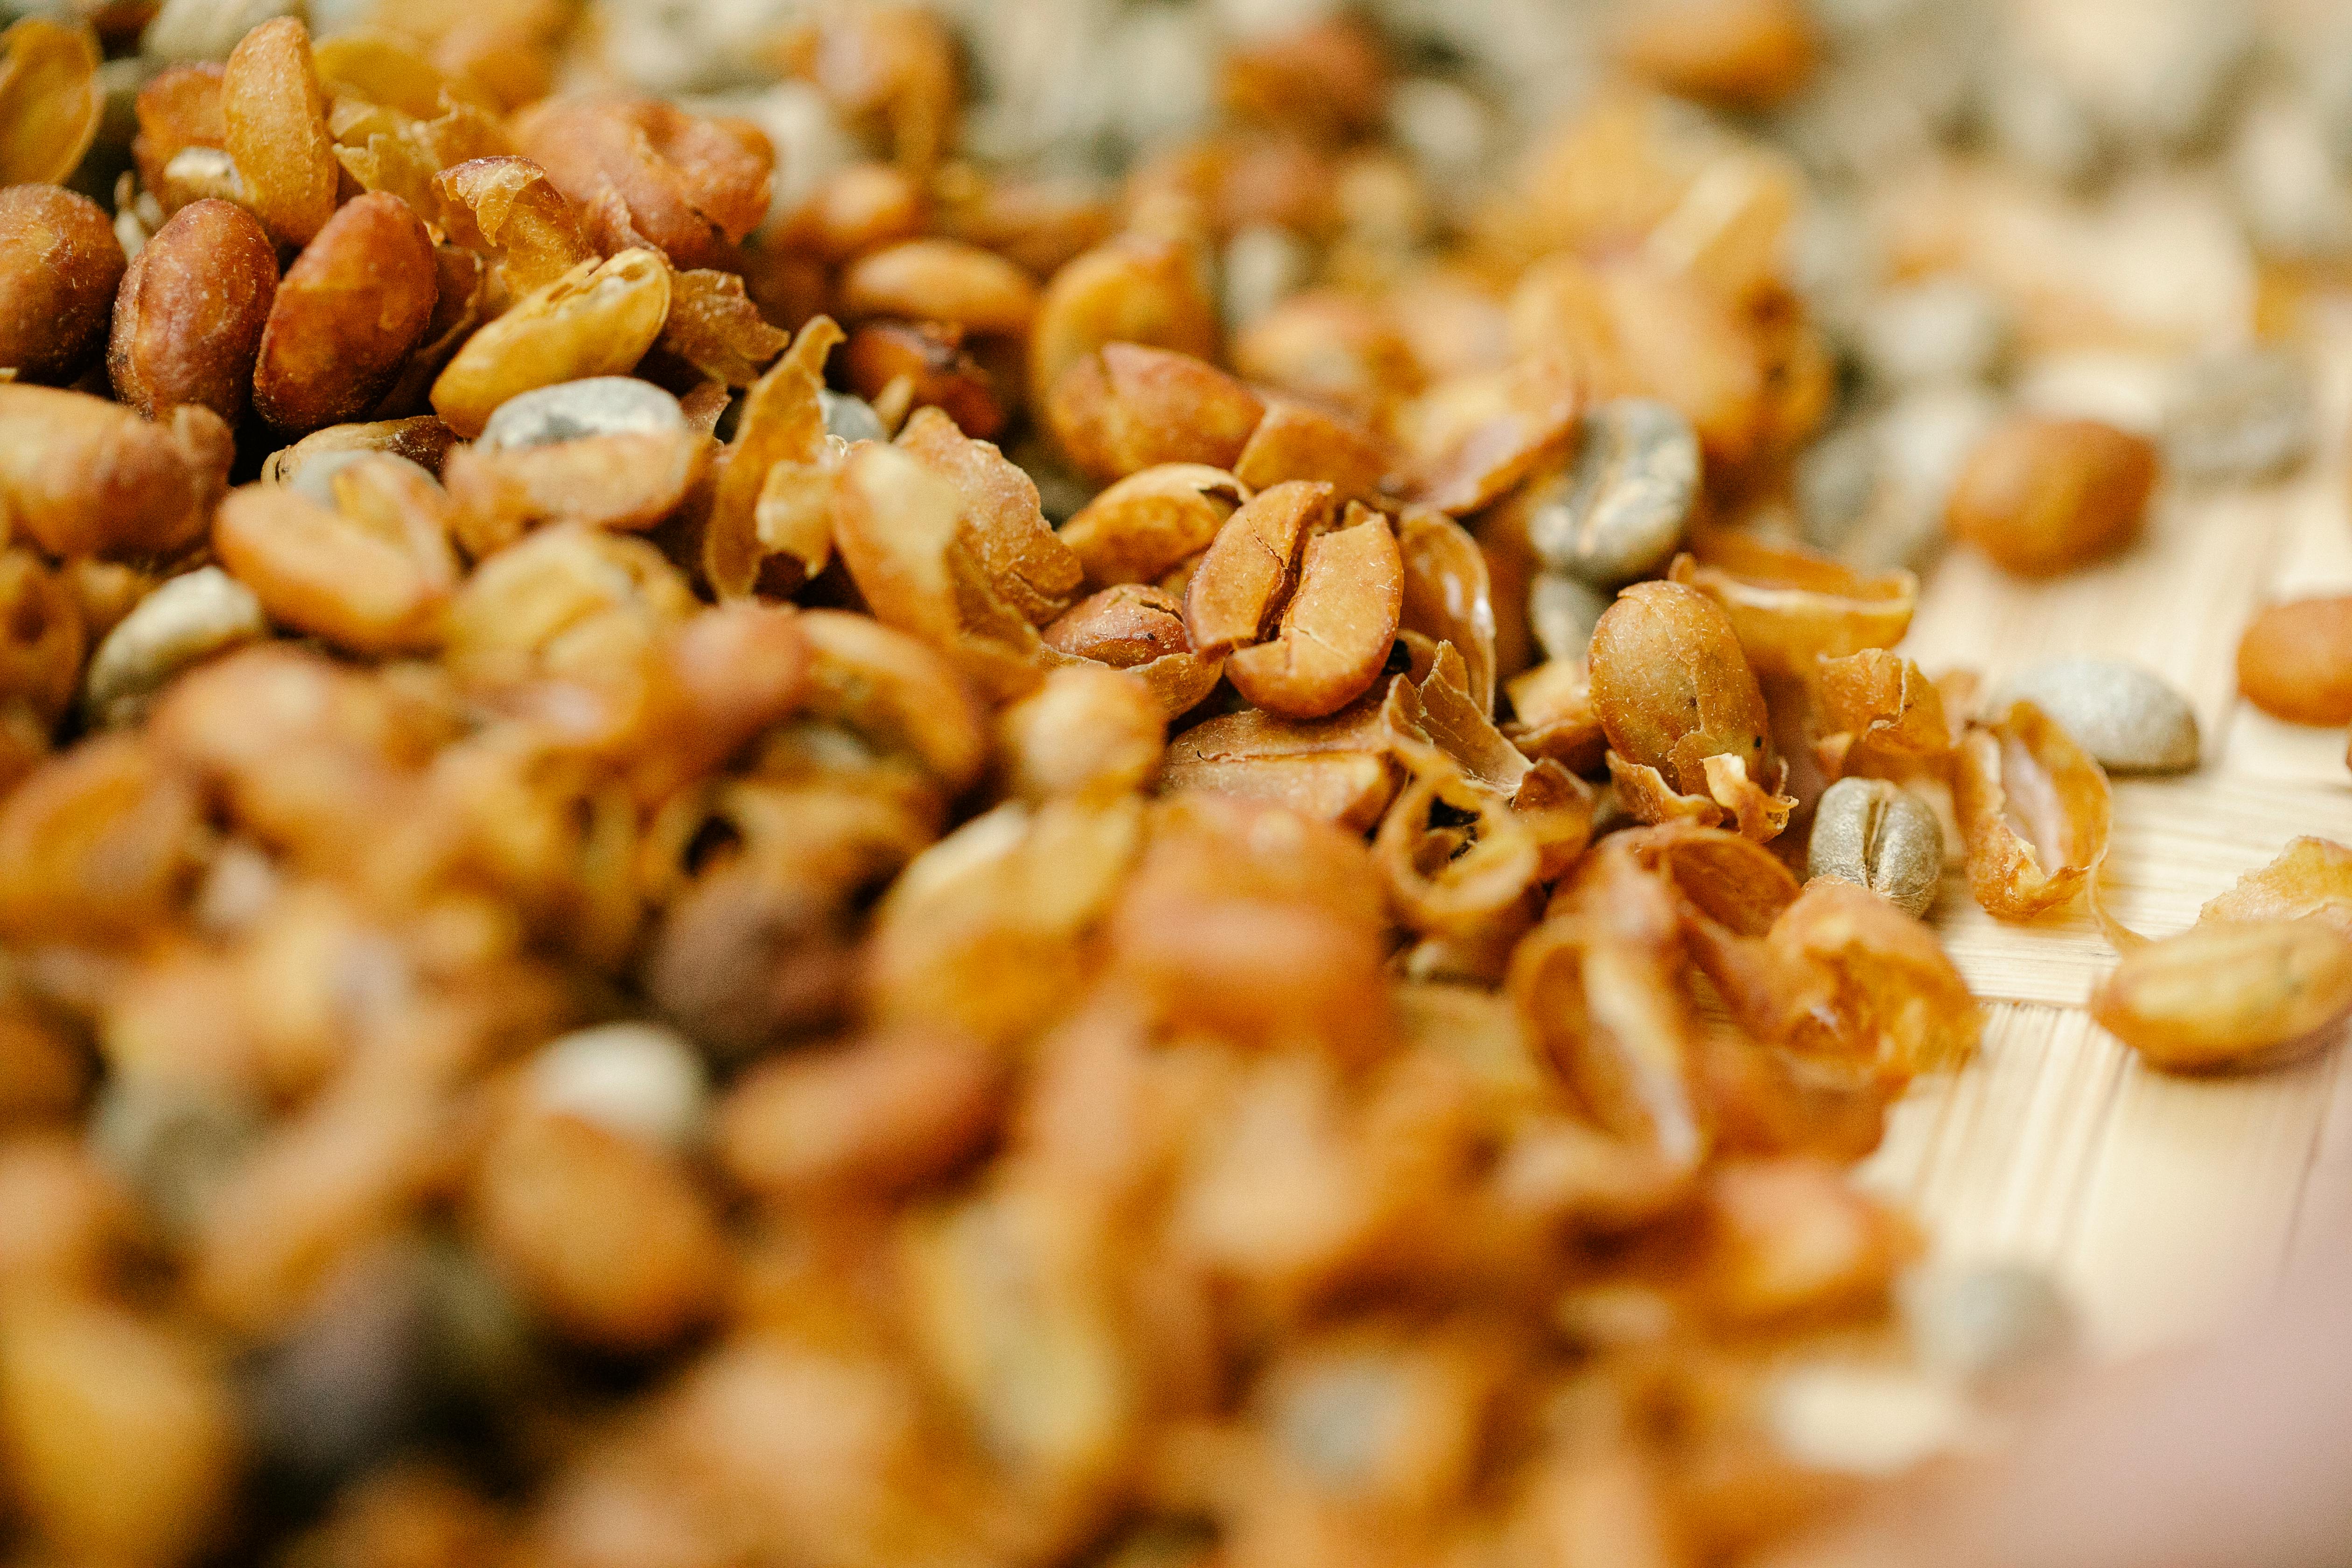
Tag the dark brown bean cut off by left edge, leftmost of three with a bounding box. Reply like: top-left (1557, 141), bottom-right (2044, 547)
top-left (0, 186), bottom-right (122, 381)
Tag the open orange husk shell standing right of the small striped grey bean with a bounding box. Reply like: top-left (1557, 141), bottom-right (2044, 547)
top-left (1952, 703), bottom-right (2114, 919)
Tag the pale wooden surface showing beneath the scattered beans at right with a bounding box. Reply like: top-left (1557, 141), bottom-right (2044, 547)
top-left (1865, 315), bottom-right (2352, 1354)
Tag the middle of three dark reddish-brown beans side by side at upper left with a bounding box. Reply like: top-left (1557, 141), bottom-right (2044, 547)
top-left (106, 200), bottom-right (278, 423)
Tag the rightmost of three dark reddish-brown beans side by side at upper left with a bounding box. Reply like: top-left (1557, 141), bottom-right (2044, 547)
top-left (254, 190), bottom-right (440, 430)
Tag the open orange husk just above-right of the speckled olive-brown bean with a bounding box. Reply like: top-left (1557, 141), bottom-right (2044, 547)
top-left (1667, 529), bottom-right (1919, 679)
